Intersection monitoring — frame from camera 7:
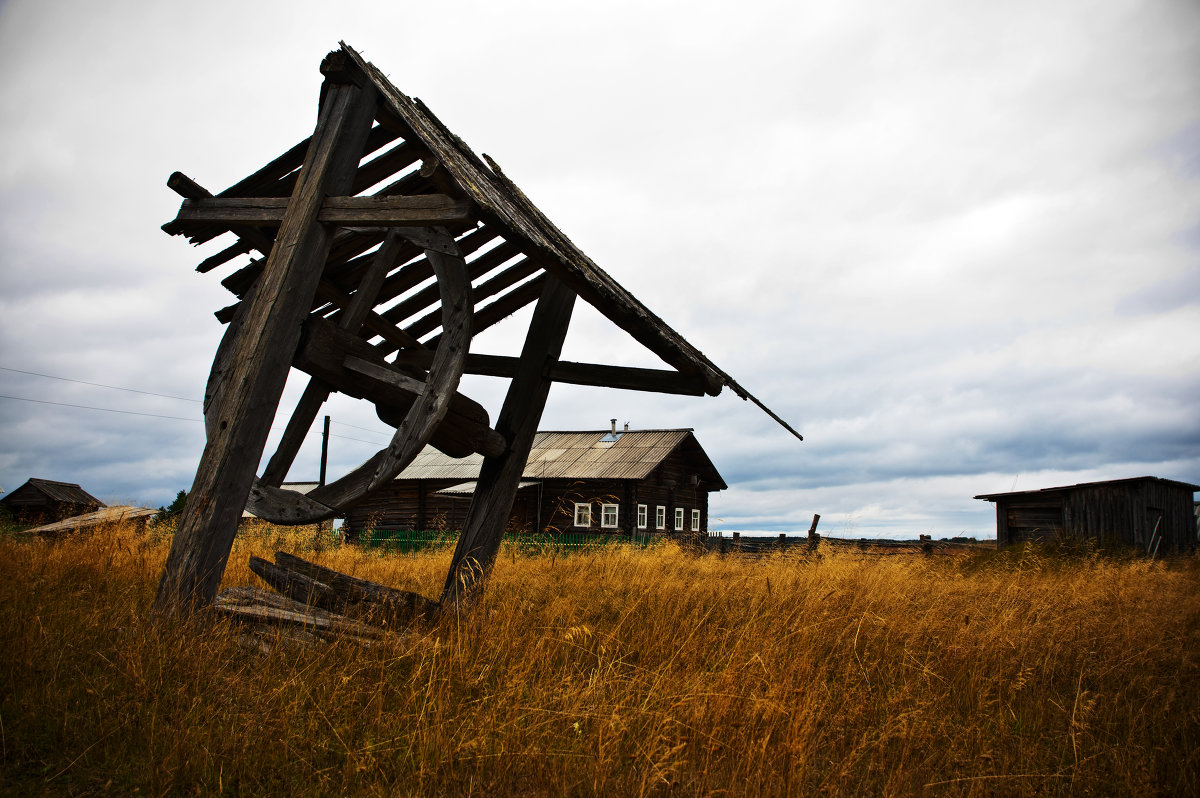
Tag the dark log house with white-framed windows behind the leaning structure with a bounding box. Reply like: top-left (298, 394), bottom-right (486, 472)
top-left (344, 424), bottom-right (727, 540)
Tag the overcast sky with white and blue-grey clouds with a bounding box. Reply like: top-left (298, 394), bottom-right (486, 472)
top-left (0, 0), bottom-right (1200, 538)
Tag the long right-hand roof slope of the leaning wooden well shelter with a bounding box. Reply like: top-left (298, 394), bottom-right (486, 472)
top-left (340, 42), bottom-right (804, 440)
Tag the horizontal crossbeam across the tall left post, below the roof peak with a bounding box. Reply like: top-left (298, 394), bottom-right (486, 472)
top-left (175, 194), bottom-right (470, 227)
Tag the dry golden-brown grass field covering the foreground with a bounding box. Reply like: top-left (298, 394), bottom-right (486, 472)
top-left (0, 527), bottom-right (1200, 796)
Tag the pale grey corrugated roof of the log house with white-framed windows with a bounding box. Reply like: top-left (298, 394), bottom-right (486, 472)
top-left (396, 428), bottom-right (727, 491)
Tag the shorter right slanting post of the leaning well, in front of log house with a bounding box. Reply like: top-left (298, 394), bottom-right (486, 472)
top-left (442, 276), bottom-right (575, 605)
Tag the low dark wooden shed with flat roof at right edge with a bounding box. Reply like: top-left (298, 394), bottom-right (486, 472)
top-left (974, 476), bottom-right (1200, 553)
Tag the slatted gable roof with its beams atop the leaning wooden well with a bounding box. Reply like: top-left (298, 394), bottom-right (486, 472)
top-left (163, 42), bottom-right (803, 440)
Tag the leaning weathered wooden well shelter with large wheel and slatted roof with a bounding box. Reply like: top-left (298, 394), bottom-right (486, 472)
top-left (157, 43), bottom-right (800, 612)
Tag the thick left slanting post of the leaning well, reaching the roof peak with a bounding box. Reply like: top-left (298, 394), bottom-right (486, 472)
top-left (155, 52), bottom-right (377, 616)
